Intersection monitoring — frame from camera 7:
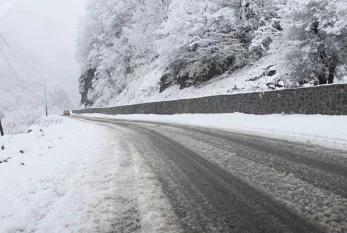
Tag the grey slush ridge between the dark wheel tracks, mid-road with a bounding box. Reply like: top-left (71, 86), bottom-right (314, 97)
top-left (150, 124), bottom-right (347, 232)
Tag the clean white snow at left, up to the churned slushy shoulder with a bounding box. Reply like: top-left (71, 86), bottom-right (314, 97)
top-left (0, 115), bottom-right (109, 232)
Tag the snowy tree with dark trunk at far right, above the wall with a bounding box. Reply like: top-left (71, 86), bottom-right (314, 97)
top-left (287, 0), bottom-right (347, 84)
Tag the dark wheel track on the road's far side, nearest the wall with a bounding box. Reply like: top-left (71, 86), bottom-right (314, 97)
top-left (161, 127), bottom-right (347, 198)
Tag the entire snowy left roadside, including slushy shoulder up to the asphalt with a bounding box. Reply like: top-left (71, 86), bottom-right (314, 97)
top-left (0, 117), bottom-right (181, 233)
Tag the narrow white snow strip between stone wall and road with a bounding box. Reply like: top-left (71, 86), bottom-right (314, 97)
top-left (83, 113), bottom-right (347, 150)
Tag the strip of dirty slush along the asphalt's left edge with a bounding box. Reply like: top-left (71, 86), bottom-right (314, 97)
top-left (109, 127), bottom-right (183, 233)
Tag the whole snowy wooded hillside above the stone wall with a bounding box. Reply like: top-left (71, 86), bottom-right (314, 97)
top-left (77, 0), bottom-right (347, 106)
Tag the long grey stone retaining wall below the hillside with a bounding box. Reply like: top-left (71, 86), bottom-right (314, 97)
top-left (73, 84), bottom-right (347, 115)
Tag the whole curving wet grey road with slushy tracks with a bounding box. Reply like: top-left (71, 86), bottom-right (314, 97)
top-left (74, 116), bottom-right (347, 233)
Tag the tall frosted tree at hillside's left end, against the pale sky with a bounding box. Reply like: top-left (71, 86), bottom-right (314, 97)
top-left (77, 0), bottom-right (134, 105)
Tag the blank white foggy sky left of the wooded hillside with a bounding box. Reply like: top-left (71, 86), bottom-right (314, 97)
top-left (0, 0), bottom-right (87, 102)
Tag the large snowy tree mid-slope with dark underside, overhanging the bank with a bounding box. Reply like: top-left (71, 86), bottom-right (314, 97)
top-left (156, 0), bottom-right (245, 90)
